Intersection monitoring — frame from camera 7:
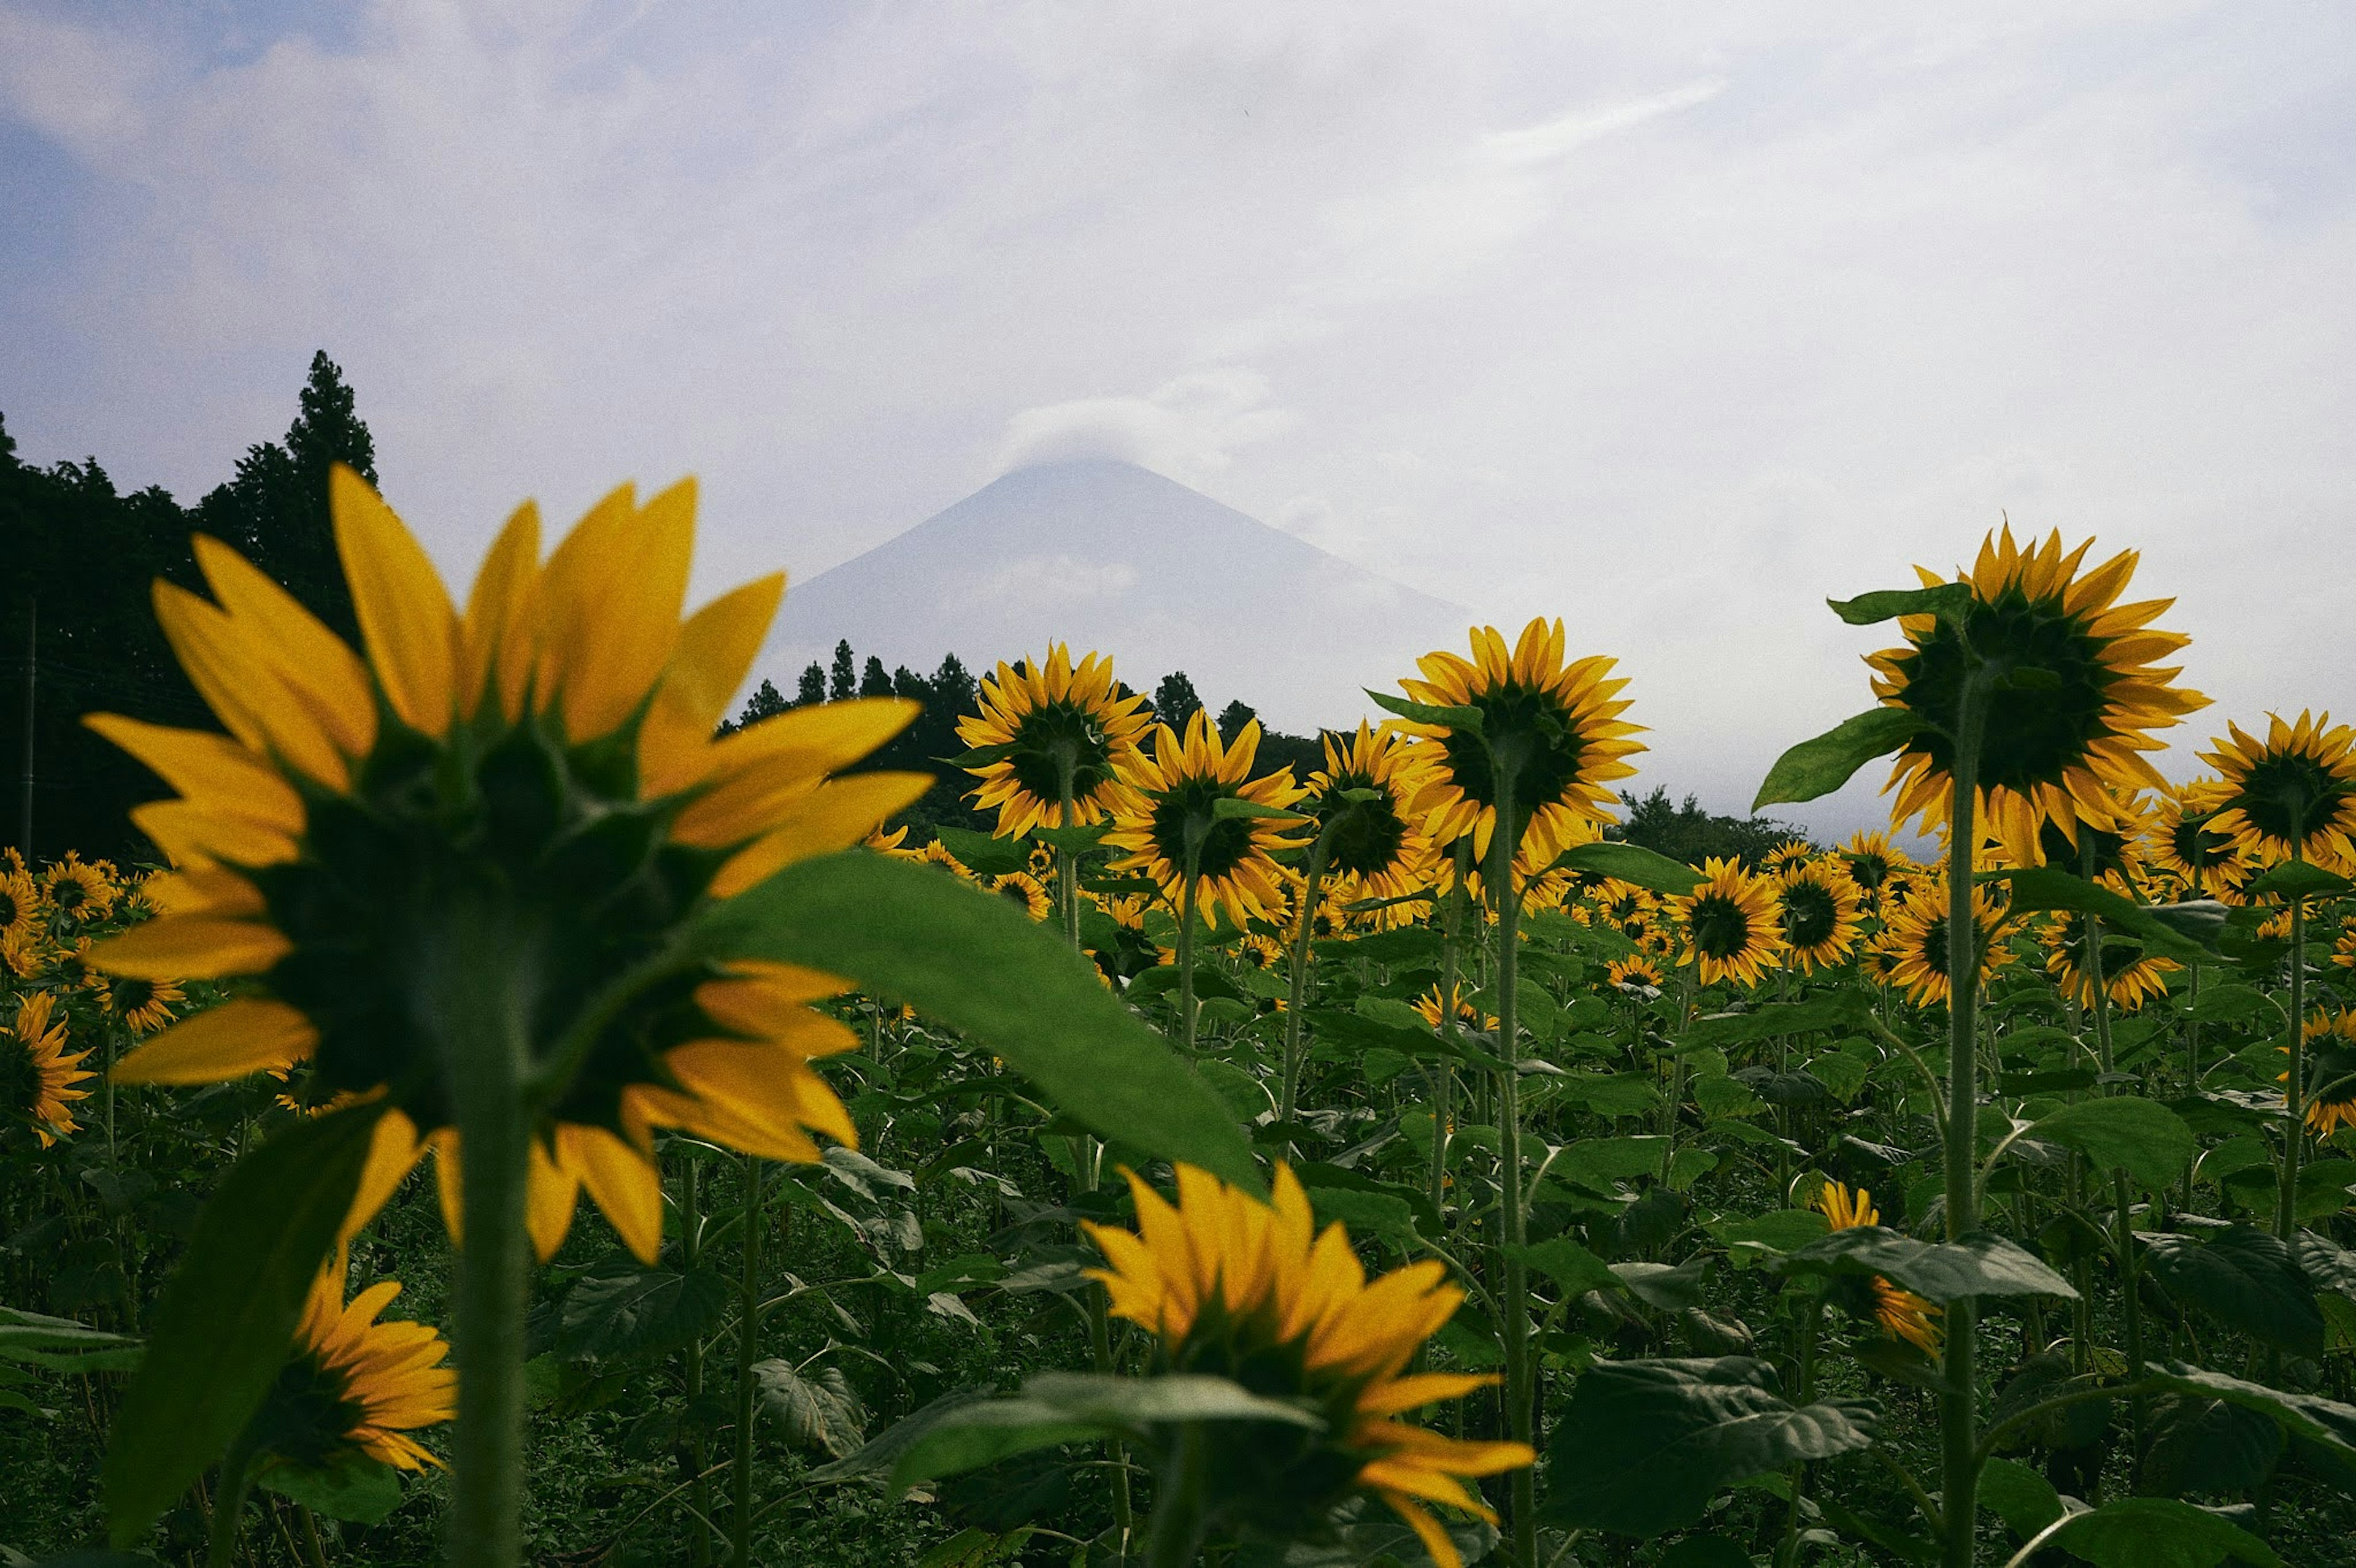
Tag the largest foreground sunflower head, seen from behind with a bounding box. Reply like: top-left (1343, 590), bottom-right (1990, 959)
top-left (87, 469), bottom-right (926, 1262)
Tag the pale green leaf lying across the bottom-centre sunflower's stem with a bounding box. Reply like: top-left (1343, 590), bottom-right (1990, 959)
top-left (891, 1372), bottom-right (1324, 1493)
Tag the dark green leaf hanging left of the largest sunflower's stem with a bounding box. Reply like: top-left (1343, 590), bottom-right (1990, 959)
top-left (104, 1102), bottom-right (384, 1547)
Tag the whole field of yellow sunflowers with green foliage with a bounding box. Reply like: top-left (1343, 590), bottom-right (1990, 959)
top-left (0, 469), bottom-right (2356, 1568)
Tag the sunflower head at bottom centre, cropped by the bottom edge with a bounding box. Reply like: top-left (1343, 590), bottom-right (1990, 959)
top-left (1084, 1166), bottom-right (1536, 1568)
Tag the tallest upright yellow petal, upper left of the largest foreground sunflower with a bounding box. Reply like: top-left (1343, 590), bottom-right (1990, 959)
top-left (328, 464), bottom-right (457, 737)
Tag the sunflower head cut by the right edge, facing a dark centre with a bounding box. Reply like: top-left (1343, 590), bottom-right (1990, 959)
top-left (2201, 711), bottom-right (2356, 869)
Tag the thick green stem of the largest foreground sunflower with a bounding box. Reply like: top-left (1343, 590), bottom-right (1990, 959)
top-left (433, 902), bottom-right (535, 1568)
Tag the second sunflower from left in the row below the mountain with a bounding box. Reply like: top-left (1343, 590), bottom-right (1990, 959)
top-left (1105, 709), bottom-right (1303, 925)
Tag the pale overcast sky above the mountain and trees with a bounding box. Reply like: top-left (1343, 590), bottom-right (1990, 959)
top-left (0, 0), bottom-right (2356, 838)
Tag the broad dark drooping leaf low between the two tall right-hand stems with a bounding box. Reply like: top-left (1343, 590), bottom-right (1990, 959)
top-left (1543, 1356), bottom-right (1873, 1537)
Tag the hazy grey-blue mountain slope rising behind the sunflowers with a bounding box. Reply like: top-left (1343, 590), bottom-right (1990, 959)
top-left (758, 461), bottom-right (1470, 732)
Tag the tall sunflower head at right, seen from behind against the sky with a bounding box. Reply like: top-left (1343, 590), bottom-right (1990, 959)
top-left (1866, 528), bottom-right (2208, 866)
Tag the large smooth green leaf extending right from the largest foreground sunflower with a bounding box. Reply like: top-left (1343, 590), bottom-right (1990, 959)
top-left (690, 852), bottom-right (1260, 1191)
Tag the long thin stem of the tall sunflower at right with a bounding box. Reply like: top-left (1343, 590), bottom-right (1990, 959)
top-left (1939, 664), bottom-right (1991, 1568)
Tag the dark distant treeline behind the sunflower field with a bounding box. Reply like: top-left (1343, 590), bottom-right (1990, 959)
top-left (0, 353), bottom-right (1800, 862)
